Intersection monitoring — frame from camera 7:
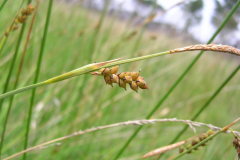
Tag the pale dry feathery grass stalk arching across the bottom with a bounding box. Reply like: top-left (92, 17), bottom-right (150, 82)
top-left (4, 118), bottom-right (240, 160)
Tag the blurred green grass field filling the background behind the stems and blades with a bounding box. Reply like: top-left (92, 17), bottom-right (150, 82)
top-left (0, 1), bottom-right (240, 159)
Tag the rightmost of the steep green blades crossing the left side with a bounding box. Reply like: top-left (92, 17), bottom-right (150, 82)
top-left (23, 0), bottom-right (53, 160)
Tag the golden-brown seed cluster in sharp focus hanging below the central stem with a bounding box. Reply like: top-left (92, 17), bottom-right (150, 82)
top-left (91, 66), bottom-right (148, 92)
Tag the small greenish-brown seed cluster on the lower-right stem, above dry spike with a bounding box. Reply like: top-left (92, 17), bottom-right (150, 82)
top-left (179, 130), bottom-right (214, 153)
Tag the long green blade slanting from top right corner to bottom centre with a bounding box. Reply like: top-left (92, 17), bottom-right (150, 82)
top-left (114, 0), bottom-right (240, 159)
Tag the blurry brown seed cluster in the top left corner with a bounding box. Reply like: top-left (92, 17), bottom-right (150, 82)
top-left (5, 4), bottom-right (35, 36)
